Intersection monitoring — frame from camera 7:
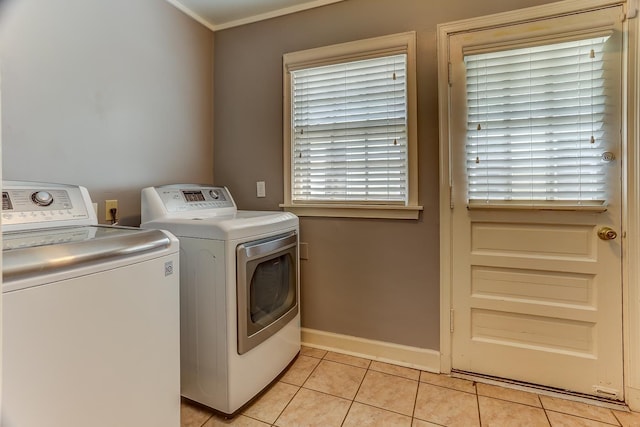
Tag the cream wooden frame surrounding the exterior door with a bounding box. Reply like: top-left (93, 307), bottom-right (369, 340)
top-left (437, 0), bottom-right (640, 410)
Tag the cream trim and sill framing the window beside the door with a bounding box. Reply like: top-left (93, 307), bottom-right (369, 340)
top-left (280, 31), bottom-right (423, 219)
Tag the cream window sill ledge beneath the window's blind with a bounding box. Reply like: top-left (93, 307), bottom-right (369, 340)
top-left (280, 204), bottom-right (423, 219)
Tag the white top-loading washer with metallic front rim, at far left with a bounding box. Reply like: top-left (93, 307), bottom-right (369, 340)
top-left (1, 181), bottom-right (180, 427)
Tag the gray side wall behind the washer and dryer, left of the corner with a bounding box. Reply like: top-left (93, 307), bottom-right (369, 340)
top-left (0, 0), bottom-right (214, 225)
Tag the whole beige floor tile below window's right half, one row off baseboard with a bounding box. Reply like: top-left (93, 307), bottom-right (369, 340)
top-left (355, 371), bottom-right (418, 416)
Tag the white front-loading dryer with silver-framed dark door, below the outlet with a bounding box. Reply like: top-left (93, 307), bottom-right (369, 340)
top-left (141, 184), bottom-right (300, 415)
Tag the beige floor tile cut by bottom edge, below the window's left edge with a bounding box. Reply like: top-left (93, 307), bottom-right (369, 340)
top-left (274, 388), bottom-right (351, 427)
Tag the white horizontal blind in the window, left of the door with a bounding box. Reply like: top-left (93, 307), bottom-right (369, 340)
top-left (291, 54), bottom-right (408, 204)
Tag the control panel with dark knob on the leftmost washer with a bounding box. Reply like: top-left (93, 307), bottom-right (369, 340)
top-left (2, 181), bottom-right (95, 231)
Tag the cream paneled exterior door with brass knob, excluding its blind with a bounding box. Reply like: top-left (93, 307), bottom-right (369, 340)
top-left (449, 7), bottom-right (623, 400)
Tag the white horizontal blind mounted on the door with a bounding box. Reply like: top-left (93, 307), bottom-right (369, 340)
top-left (465, 36), bottom-right (609, 205)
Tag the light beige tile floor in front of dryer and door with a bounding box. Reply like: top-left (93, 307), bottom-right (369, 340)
top-left (182, 347), bottom-right (640, 427)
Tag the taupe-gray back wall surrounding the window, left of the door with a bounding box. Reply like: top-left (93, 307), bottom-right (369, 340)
top-left (214, 0), bottom-right (550, 350)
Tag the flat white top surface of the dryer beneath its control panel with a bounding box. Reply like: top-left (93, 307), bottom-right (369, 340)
top-left (140, 211), bottom-right (298, 240)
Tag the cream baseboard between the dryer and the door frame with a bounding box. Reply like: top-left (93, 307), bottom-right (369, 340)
top-left (302, 328), bottom-right (440, 373)
